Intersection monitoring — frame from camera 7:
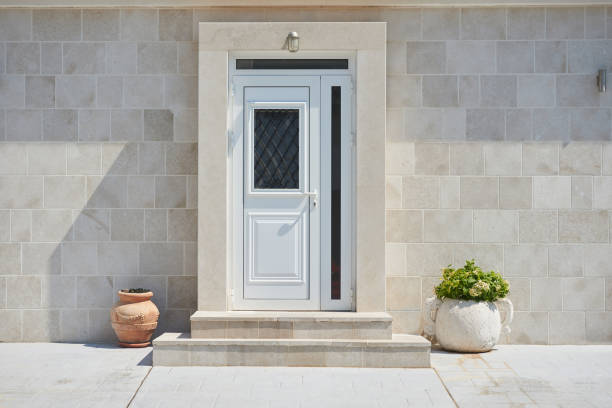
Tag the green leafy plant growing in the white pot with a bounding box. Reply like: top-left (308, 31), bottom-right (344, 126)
top-left (434, 259), bottom-right (509, 302)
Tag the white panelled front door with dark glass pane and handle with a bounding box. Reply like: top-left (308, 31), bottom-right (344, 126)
top-left (233, 76), bottom-right (321, 310)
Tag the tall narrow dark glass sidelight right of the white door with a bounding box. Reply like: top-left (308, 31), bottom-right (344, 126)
top-left (331, 86), bottom-right (342, 299)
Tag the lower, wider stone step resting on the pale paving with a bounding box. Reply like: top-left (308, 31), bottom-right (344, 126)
top-left (153, 333), bottom-right (431, 368)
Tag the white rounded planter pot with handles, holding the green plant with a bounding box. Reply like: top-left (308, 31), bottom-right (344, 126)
top-left (424, 297), bottom-right (514, 352)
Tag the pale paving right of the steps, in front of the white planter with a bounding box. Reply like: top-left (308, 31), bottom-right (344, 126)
top-left (431, 346), bottom-right (612, 408)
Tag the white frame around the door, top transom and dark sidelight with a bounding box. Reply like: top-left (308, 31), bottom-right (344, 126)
top-left (228, 52), bottom-right (356, 311)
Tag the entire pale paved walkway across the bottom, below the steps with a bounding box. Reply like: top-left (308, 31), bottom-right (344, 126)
top-left (0, 343), bottom-right (612, 408)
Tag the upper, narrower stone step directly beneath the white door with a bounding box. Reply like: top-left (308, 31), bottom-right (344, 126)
top-left (191, 311), bottom-right (393, 340)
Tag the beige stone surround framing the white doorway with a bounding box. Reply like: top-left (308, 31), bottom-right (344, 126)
top-left (198, 22), bottom-right (386, 312)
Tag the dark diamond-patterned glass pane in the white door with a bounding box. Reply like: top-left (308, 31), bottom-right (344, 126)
top-left (254, 109), bottom-right (300, 189)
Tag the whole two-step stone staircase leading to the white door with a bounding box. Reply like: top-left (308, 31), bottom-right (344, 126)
top-left (153, 311), bottom-right (431, 367)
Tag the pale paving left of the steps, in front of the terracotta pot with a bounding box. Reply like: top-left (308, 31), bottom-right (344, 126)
top-left (0, 343), bottom-right (151, 408)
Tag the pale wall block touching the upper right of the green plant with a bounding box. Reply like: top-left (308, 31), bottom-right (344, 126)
top-left (504, 245), bottom-right (548, 277)
